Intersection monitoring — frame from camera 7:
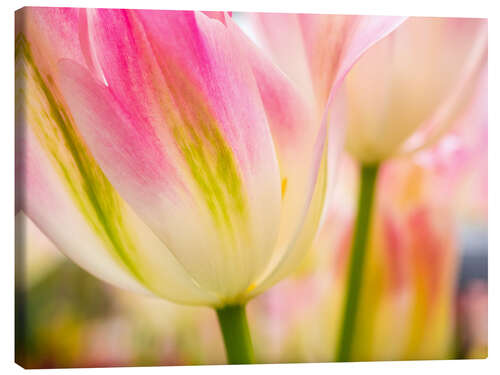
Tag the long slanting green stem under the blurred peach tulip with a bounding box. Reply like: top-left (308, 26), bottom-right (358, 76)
top-left (336, 165), bottom-right (378, 362)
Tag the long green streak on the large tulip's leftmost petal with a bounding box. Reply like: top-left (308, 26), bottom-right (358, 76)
top-left (15, 34), bottom-right (145, 284)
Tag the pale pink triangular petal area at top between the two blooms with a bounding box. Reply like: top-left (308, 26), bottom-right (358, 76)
top-left (254, 13), bottom-right (405, 112)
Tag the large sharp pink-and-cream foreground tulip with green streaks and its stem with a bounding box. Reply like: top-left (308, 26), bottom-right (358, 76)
top-left (16, 8), bottom-right (406, 363)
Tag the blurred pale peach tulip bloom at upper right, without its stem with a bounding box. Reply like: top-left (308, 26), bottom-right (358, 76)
top-left (345, 17), bottom-right (487, 163)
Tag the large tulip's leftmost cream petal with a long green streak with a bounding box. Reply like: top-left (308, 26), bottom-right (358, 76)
top-left (16, 32), bottom-right (215, 304)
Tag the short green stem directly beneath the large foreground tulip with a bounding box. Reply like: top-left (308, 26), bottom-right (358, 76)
top-left (216, 305), bottom-right (254, 364)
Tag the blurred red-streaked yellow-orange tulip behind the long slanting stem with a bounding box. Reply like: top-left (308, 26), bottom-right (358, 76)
top-left (318, 160), bottom-right (459, 361)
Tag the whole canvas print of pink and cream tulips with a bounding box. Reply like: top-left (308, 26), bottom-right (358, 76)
top-left (15, 7), bottom-right (488, 368)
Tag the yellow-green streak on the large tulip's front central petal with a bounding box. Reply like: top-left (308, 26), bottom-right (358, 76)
top-left (145, 54), bottom-right (250, 245)
